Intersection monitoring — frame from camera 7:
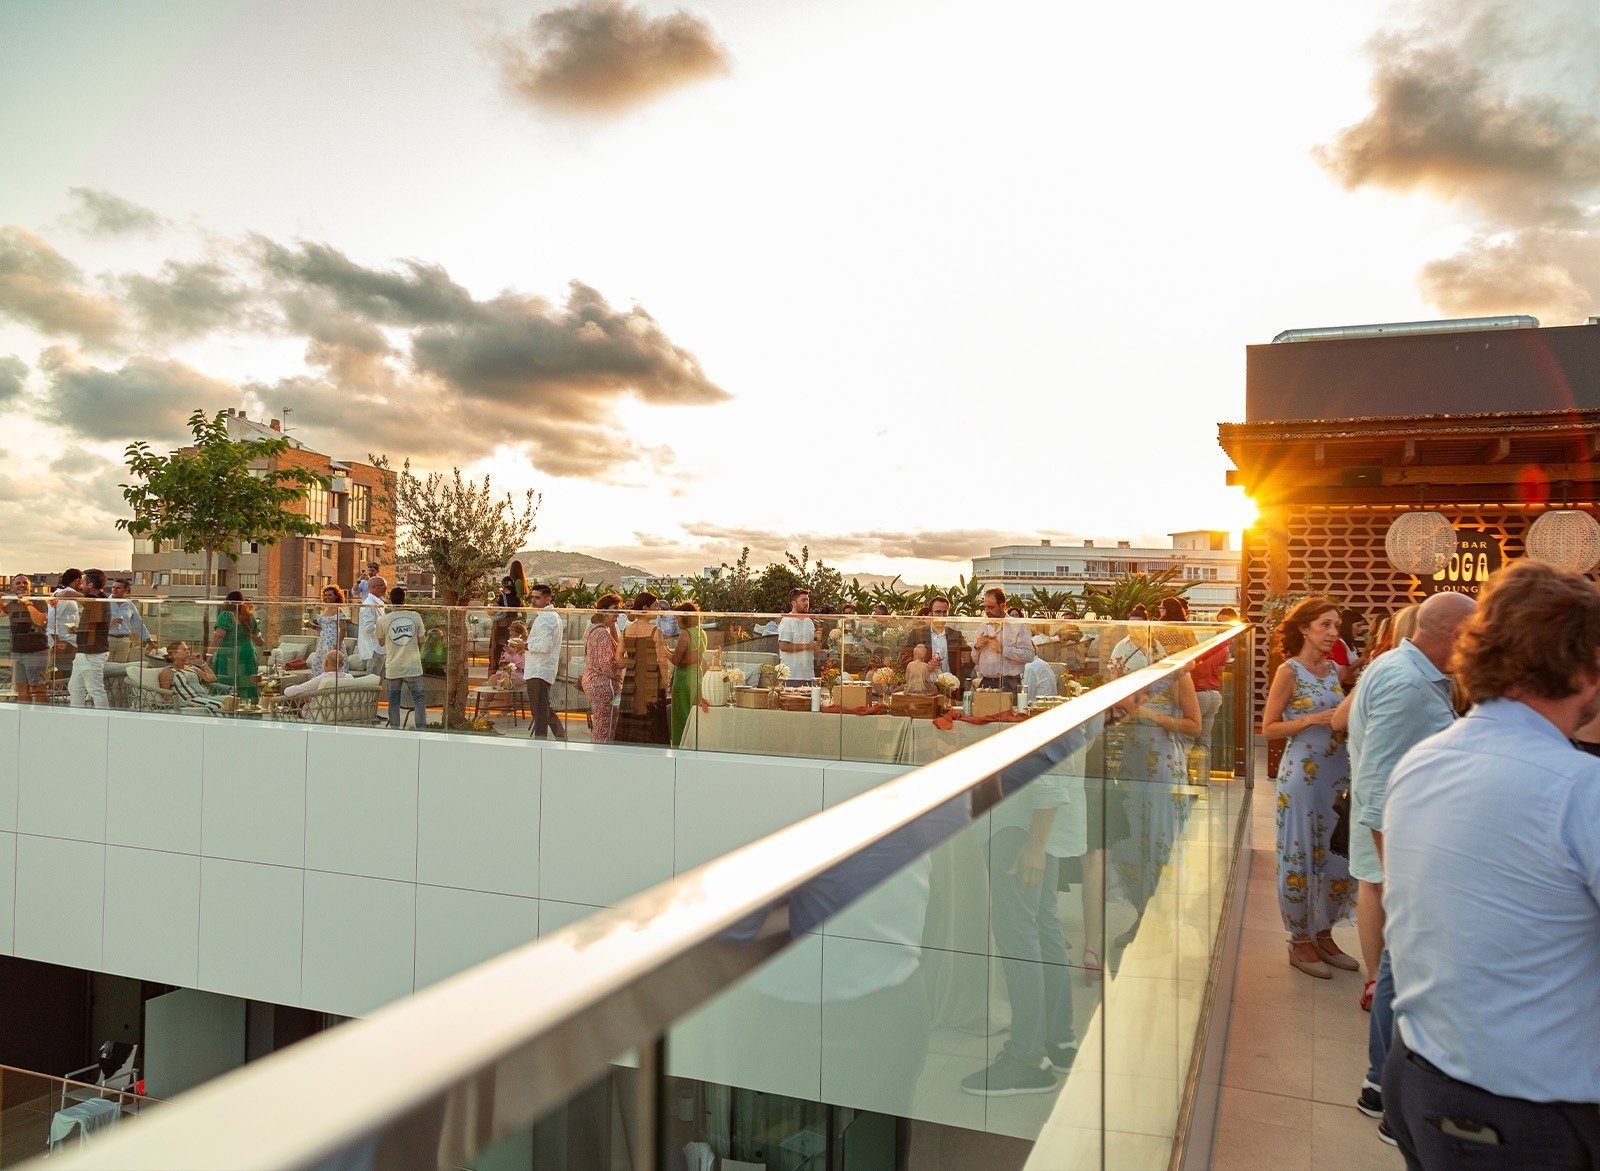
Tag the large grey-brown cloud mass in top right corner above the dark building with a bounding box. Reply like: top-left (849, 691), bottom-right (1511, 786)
top-left (1314, 0), bottom-right (1600, 320)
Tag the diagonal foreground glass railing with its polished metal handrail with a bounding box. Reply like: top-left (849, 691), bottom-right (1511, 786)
top-left (34, 627), bottom-right (1251, 1171)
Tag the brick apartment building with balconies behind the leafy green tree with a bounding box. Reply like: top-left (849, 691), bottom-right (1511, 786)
top-left (133, 410), bottom-right (395, 598)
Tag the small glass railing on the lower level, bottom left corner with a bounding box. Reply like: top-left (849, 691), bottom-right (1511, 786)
top-left (0, 1065), bottom-right (157, 1168)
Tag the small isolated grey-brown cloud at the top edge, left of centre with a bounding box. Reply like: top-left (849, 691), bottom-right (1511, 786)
top-left (493, 0), bottom-right (730, 115)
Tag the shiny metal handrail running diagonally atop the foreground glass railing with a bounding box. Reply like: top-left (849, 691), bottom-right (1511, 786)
top-left (46, 624), bottom-right (1248, 1171)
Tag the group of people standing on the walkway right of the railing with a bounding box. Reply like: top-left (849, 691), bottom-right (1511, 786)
top-left (1262, 562), bottom-right (1600, 1171)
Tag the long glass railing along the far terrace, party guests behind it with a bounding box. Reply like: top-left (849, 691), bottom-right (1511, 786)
top-left (0, 597), bottom-right (1234, 773)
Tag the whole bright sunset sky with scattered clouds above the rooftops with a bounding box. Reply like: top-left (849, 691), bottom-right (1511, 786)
top-left (0, 0), bottom-right (1600, 582)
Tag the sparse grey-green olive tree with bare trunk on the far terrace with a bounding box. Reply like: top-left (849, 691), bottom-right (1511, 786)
top-left (370, 456), bottom-right (539, 726)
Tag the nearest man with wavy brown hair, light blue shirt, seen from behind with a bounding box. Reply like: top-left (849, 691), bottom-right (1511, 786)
top-left (1382, 562), bottom-right (1600, 1169)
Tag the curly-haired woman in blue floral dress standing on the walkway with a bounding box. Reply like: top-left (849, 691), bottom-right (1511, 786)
top-left (1261, 598), bottom-right (1360, 979)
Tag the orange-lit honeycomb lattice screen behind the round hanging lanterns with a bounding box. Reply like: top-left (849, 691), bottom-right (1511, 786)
top-left (1245, 504), bottom-right (1533, 703)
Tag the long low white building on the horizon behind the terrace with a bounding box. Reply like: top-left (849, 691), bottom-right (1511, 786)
top-left (973, 530), bottom-right (1240, 617)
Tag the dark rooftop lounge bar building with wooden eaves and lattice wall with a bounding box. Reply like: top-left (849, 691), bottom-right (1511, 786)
top-left (1219, 318), bottom-right (1600, 700)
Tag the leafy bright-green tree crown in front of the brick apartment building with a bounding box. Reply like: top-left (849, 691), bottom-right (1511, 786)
top-left (117, 410), bottom-right (328, 598)
